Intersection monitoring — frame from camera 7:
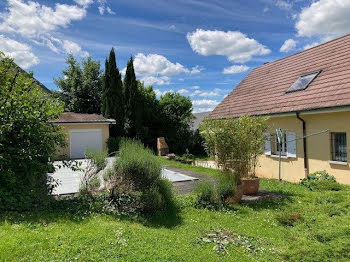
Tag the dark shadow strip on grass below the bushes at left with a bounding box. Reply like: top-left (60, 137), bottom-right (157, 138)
top-left (0, 194), bottom-right (182, 228)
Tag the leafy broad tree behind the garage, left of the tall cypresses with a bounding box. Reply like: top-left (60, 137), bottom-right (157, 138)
top-left (54, 54), bottom-right (102, 114)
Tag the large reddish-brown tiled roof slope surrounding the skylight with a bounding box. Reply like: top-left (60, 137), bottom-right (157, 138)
top-left (210, 35), bottom-right (350, 118)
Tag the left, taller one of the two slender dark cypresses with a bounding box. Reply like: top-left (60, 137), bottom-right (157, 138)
top-left (102, 48), bottom-right (125, 136)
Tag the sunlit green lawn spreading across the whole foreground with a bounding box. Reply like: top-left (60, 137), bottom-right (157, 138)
top-left (0, 165), bottom-right (350, 261)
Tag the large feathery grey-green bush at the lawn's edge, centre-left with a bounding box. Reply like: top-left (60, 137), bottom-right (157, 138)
top-left (110, 140), bottom-right (175, 214)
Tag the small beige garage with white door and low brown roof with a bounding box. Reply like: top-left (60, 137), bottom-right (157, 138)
top-left (52, 112), bottom-right (116, 159)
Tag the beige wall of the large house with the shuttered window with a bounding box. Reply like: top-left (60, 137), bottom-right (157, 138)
top-left (257, 112), bottom-right (350, 184)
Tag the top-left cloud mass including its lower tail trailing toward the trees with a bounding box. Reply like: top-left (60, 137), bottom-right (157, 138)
top-left (0, 0), bottom-right (92, 59)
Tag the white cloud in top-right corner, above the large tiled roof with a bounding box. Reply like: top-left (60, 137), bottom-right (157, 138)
top-left (295, 0), bottom-right (350, 40)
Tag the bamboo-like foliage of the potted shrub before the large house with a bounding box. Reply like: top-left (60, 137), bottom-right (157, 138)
top-left (200, 116), bottom-right (267, 183)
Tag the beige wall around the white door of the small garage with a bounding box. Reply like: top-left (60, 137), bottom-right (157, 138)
top-left (57, 123), bottom-right (109, 158)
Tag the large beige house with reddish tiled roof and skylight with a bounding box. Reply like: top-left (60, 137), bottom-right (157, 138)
top-left (209, 35), bottom-right (350, 184)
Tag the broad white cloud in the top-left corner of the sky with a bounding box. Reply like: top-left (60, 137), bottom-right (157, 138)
top-left (0, 0), bottom-right (86, 37)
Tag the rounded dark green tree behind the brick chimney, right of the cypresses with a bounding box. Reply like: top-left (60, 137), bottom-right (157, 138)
top-left (159, 93), bottom-right (193, 154)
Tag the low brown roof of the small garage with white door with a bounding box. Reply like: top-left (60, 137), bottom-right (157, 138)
top-left (52, 112), bottom-right (115, 124)
